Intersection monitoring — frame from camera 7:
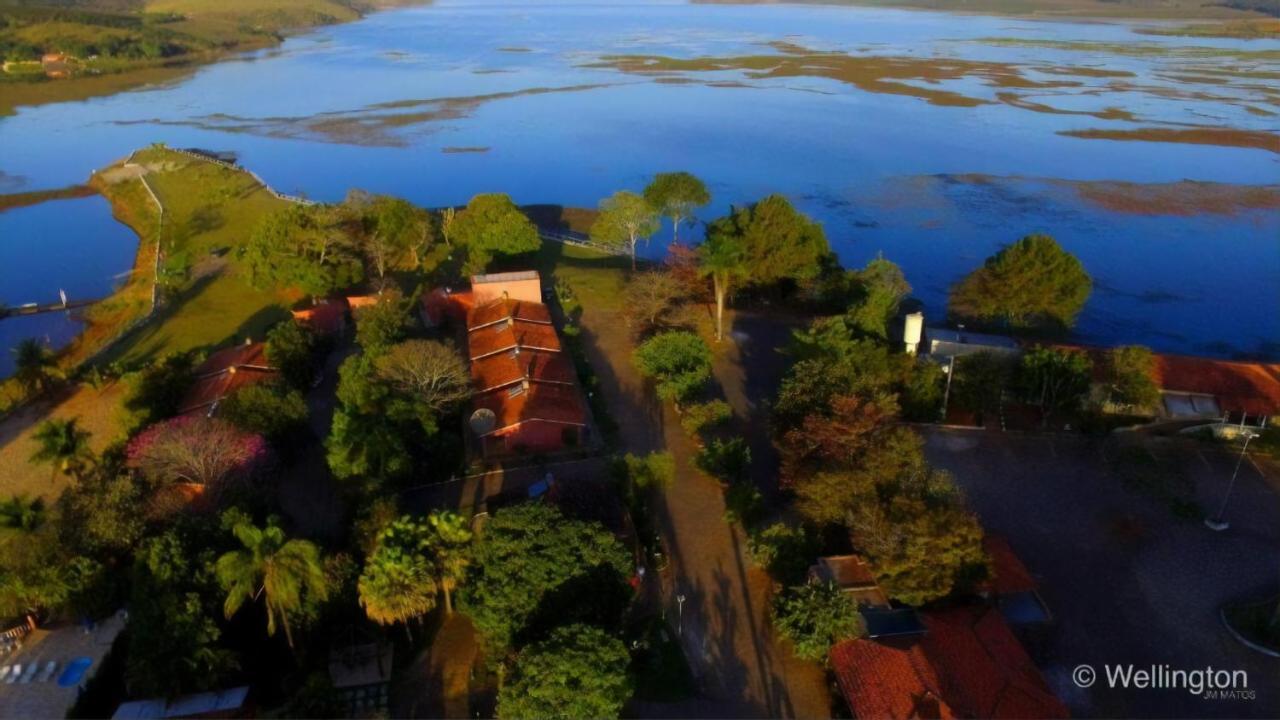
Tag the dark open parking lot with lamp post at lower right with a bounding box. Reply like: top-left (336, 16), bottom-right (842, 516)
top-left (924, 429), bottom-right (1280, 717)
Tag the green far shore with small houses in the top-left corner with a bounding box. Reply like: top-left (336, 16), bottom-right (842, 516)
top-left (0, 0), bottom-right (430, 117)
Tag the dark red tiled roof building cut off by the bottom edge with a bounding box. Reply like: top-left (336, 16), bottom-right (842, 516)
top-left (831, 606), bottom-right (1069, 720)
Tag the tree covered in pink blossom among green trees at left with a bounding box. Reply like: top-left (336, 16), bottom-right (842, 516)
top-left (125, 415), bottom-right (268, 496)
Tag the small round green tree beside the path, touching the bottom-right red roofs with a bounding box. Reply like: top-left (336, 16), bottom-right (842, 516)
top-left (773, 583), bottom-right (867, 662)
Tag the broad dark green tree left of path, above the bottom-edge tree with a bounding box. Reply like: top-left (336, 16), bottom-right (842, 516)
top-left (460, 503), bottom-right (631, 651)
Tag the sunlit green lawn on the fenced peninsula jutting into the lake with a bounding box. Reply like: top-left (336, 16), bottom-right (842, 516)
top-left (100, 149), bottom-right (291, 365)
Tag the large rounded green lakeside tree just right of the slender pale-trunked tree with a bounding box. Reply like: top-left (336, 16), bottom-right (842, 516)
top-left (707, 195), bottom-right (831, 284)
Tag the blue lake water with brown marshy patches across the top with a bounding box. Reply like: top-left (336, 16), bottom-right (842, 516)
top-left (0, 1), bottom-right (1280, 372)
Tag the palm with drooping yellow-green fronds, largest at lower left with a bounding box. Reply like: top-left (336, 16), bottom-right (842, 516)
top-left (214, 519), bottom-right (329, 648)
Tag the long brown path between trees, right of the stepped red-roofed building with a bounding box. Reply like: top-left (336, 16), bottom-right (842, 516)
top-left (582, 303), bottom-right (831, 717)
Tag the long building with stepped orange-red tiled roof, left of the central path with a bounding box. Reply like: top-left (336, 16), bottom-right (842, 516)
top-left (465, 270), bottom-right (588, 456)
